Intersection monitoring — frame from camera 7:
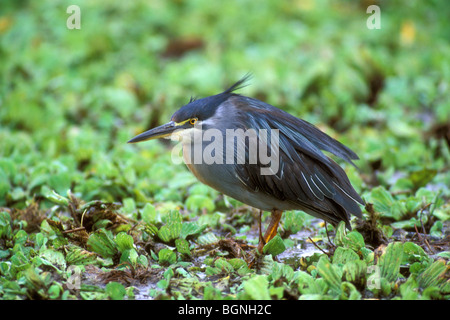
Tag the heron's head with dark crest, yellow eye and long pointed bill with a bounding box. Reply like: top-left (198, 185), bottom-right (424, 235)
top-left (128, 75), bottom-right (249, 143)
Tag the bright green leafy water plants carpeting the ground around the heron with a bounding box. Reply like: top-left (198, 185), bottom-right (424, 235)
top-left (0, 0), bottom-right (450, 299)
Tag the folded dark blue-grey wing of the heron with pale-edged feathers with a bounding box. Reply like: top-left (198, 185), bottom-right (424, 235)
top-left (230, 99), bottom-right (363, 226)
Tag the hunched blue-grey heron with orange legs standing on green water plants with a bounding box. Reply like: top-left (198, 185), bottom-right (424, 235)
top-left (128, 75), bottom-right (363, 252)
